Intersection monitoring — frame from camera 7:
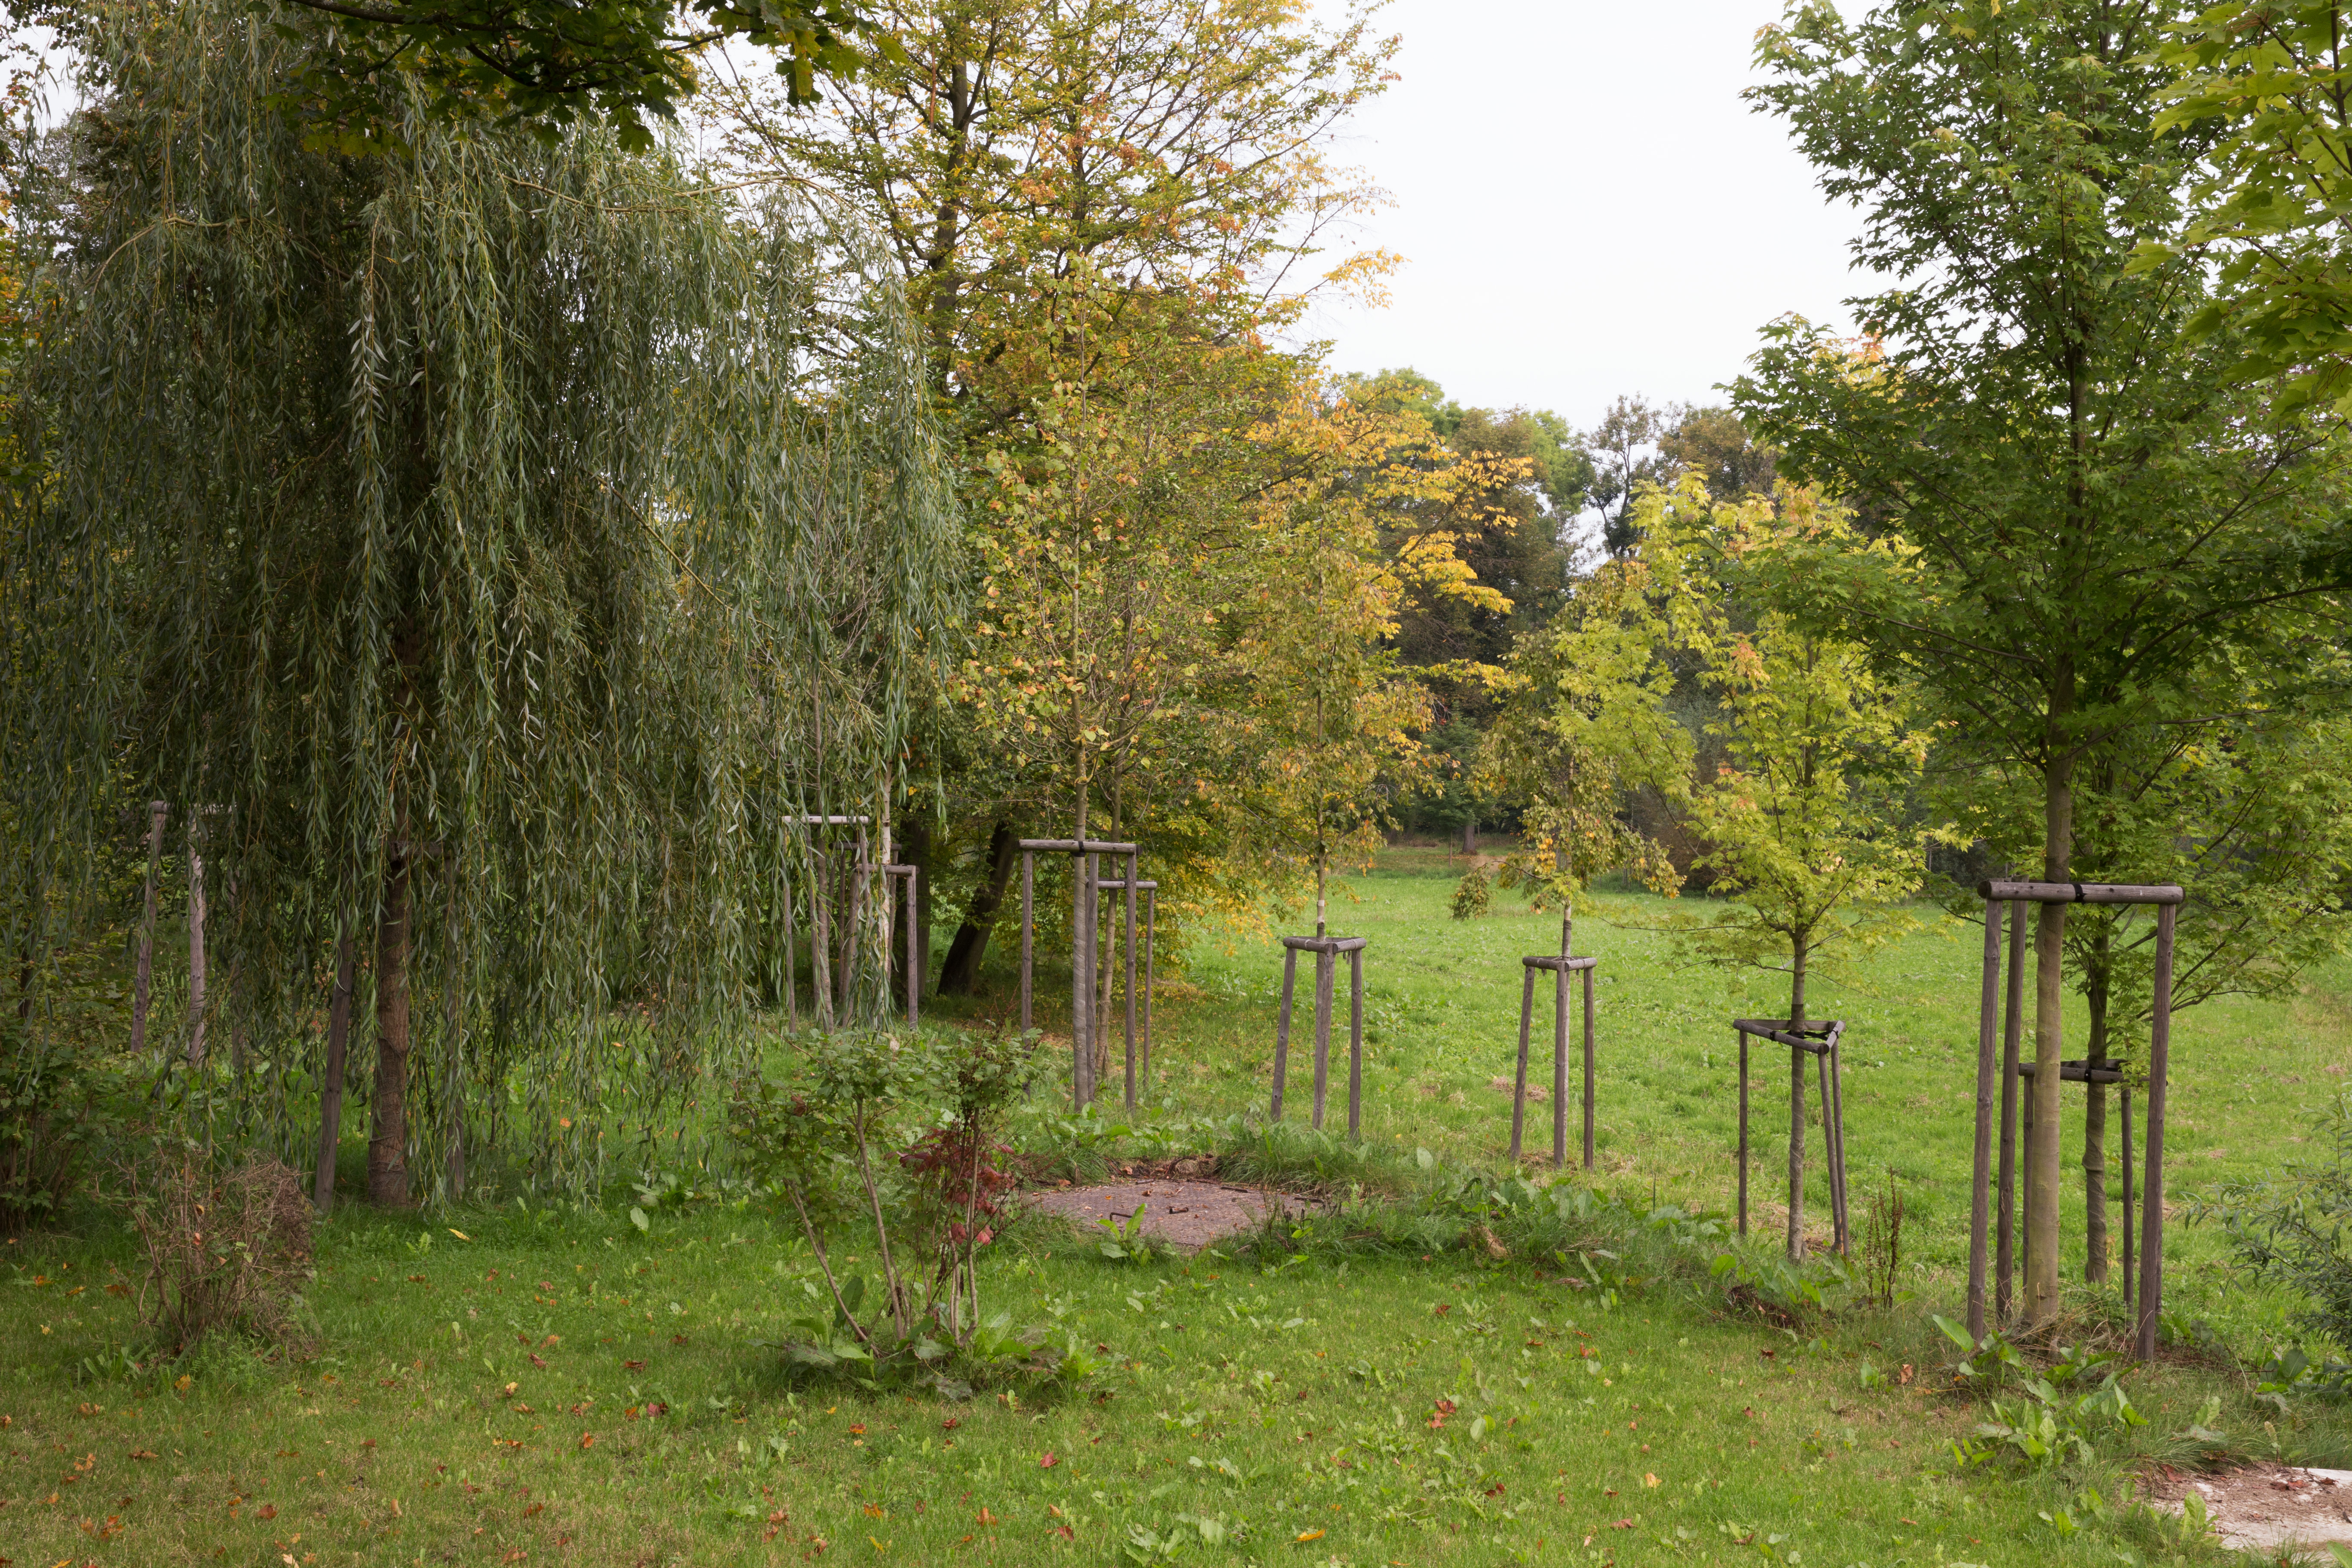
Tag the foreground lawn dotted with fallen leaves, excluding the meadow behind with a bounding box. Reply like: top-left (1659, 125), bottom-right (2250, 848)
top-left (0, 1189), bottom-right (2340, 1568)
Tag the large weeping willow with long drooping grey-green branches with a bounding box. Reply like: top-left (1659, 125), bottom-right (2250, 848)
top-left (7, 0), bottom-right (955, 1204)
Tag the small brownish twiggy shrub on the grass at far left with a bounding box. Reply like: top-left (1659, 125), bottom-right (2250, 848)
top-left (122, 1142), bottom-right (310, 1354)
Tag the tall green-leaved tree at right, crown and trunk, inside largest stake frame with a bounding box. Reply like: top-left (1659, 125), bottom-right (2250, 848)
top-left (1736, 0), bottom-right (2340, 1323)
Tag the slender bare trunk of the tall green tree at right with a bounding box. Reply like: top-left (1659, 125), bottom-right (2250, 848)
top-left (2018, 700), bottom-right (2074, 1328)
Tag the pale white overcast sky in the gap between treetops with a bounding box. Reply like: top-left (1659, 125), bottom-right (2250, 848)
top-left (1308, 0), bottom-right (1882, 428)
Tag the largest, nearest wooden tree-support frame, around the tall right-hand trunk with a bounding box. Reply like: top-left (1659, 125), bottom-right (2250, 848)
top-left (1969, 882), bottom-right (2185, 1361)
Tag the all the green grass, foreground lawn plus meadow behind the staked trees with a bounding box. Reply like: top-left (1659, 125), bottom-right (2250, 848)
top-left (0, 851), bottom-right (2352, 1568)
